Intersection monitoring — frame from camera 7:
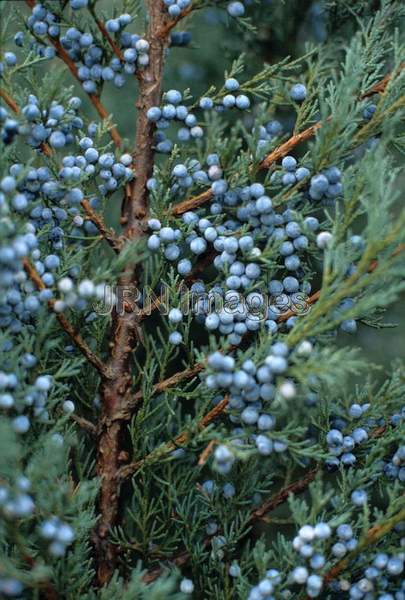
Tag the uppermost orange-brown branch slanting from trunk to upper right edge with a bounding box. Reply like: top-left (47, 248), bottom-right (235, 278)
top-left (170, 68), bottom-right (398, 217)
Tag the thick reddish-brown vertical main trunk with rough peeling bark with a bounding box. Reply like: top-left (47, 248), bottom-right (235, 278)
top-left (94, 0), bottom-right (174, 587)
